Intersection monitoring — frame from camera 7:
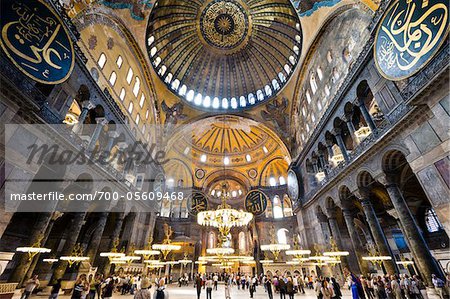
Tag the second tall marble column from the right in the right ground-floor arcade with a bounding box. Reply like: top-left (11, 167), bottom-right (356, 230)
top-left (359, 190), bottom-right (399, 274)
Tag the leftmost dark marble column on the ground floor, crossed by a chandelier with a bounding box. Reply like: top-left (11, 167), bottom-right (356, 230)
top-left (8, 213), bottom-right (52, 288)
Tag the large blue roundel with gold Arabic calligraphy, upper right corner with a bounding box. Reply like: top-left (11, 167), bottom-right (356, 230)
top-left (374, 0), bottom-right (449, 80)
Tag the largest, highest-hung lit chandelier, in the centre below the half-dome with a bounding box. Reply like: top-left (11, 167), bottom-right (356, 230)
top-left (197, 183), bottom-right (253, 237)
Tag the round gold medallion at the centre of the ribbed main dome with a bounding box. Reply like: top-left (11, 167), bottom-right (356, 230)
top-left (200, 0), bottom-right (249, 49)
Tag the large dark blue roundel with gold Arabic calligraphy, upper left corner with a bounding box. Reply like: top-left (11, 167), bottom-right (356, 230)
top-left (1, 0), bottom-right (74, 84)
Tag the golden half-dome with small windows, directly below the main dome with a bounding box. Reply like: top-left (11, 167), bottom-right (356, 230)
top-left (164, 115), bottom-right (290, 191)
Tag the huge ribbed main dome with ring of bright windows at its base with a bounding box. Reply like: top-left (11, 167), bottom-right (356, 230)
top-left (147, 0), bottom-right (302, 111)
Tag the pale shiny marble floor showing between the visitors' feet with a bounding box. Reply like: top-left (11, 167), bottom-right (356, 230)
top-left (13, 285), bottom-right (351, 299)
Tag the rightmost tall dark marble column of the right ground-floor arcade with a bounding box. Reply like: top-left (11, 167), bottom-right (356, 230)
top-left (385, 174), bottom-right (443, 286)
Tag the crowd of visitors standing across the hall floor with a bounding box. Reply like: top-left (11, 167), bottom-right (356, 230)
top-left (21, 268), bottom-right (450, 299)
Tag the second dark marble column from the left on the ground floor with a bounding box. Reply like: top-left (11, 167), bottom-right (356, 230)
top-left (50, 212), bottom-right (86, 283)
